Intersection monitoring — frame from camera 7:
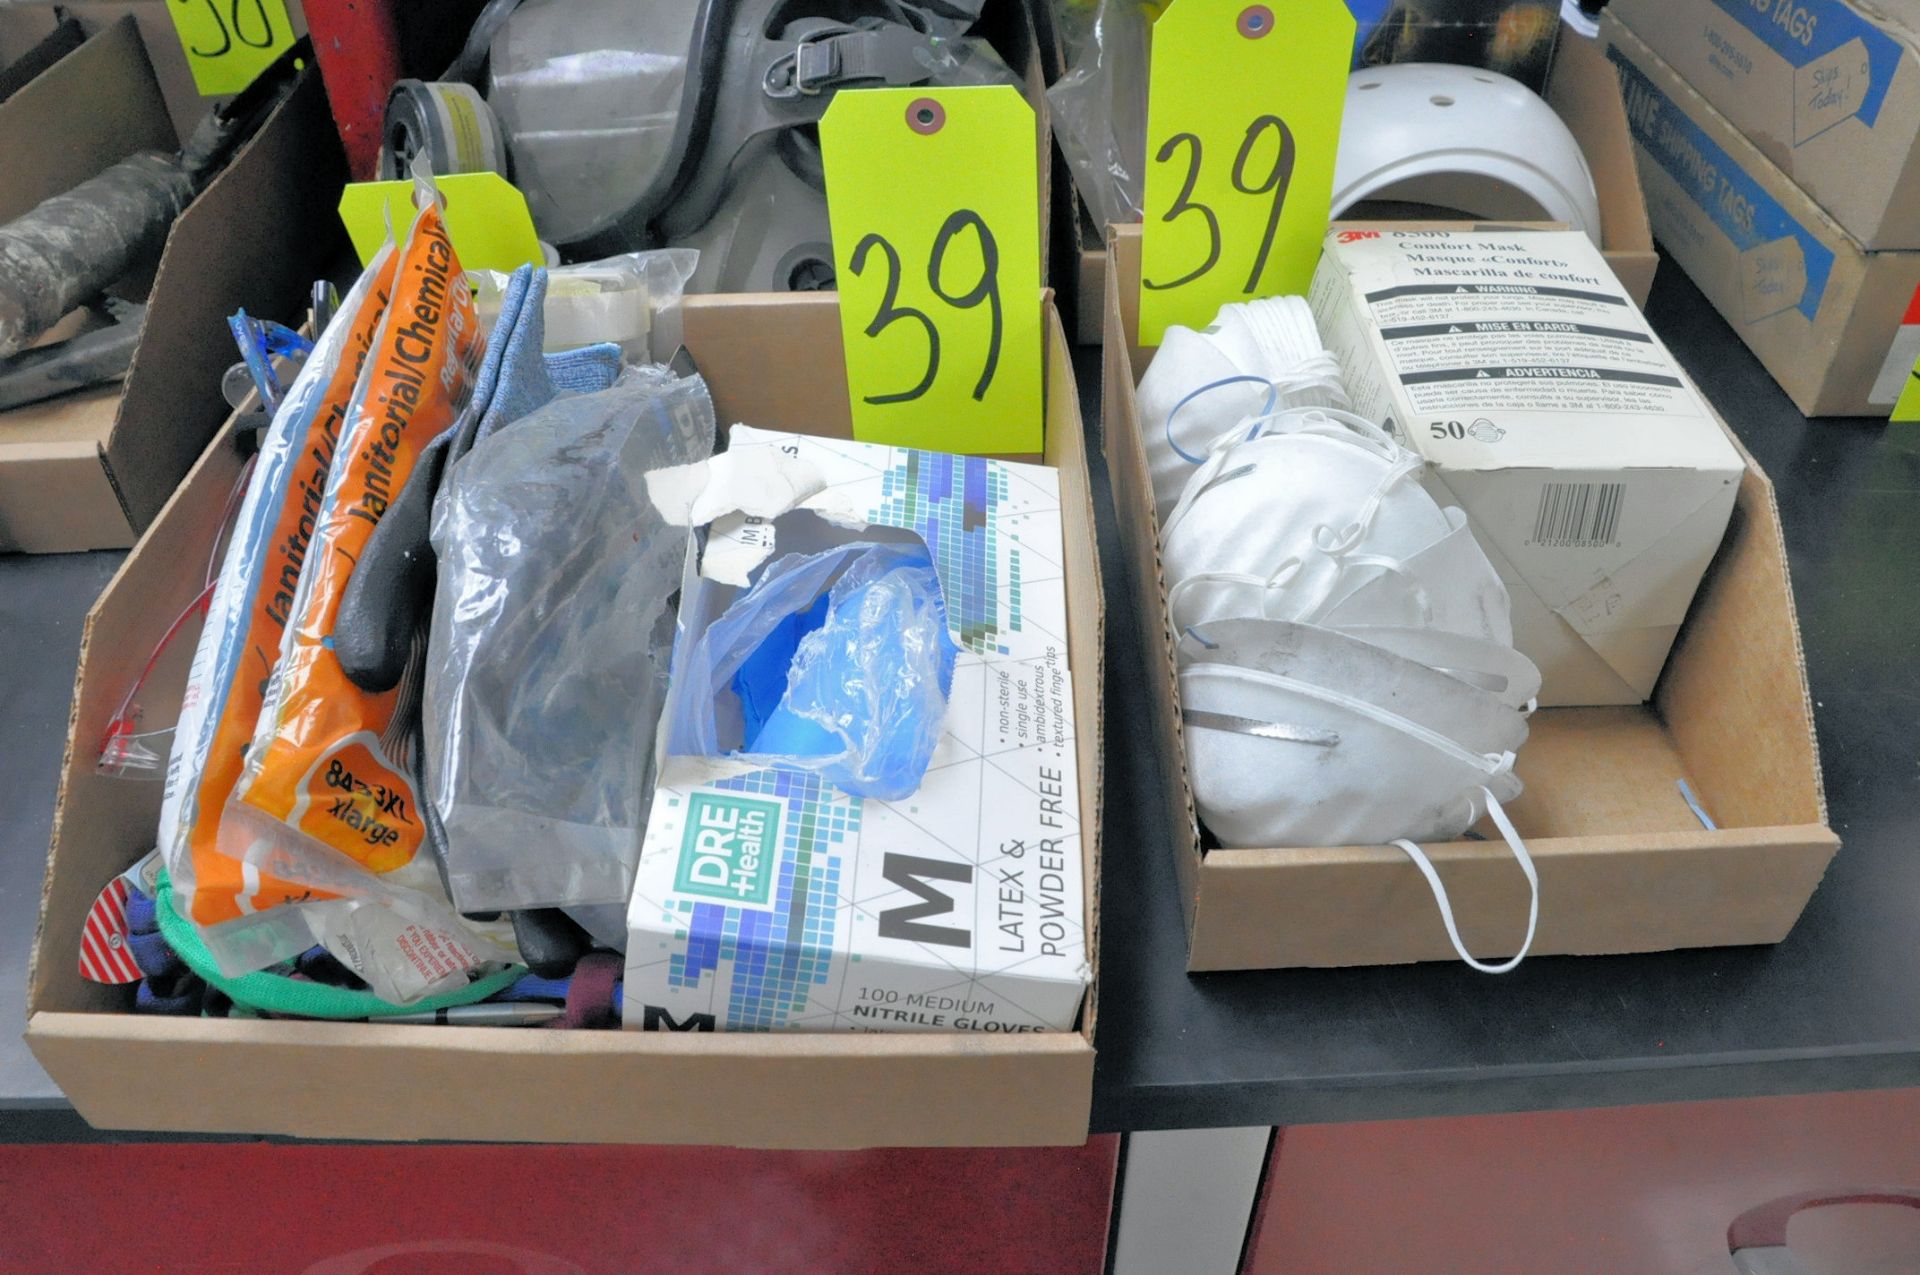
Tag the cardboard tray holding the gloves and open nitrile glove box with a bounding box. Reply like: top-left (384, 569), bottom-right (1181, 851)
top-left (27, 294), bottom-right (1102, 1148)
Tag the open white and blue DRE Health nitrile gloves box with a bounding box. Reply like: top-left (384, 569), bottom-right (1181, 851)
top-left (624, 426), bottom-right (1089, 1033)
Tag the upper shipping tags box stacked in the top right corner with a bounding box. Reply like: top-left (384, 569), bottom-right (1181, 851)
top-left (1607, 0), bottom-right (1920, 250)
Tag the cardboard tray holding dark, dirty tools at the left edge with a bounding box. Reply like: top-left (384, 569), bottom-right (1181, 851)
top-left (0, 19), bottom-right (346, 553)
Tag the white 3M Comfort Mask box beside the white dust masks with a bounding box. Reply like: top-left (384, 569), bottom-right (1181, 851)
top-left (1311, 229), bottom-right (1745, 705)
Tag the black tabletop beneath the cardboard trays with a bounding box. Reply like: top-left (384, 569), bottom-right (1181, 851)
top-left (0, 265), bottom-right (1920, 1137)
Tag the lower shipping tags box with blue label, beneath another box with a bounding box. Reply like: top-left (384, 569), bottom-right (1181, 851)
top-left (1601, 19), bottom-right (1920, 417)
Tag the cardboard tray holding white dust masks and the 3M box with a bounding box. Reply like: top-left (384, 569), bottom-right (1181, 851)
top-left (1102, 230), bottom-right (1839, 970)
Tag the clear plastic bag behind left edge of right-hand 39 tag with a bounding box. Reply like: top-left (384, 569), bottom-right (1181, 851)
top-left (1046, 0), bottom-right (1162, 234)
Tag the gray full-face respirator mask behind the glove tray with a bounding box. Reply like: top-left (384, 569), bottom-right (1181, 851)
top-left (380, 0), bottom-right (1020, 292)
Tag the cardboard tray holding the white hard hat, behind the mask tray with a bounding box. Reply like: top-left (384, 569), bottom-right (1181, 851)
top-left (1071, 36), bottom-right (1661, 346)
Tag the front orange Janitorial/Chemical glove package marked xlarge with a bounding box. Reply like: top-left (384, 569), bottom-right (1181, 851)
top-left (219, 186), bottom-right (511, 1002)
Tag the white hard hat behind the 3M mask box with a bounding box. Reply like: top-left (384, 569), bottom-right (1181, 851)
top-left (1332, 61), bottom-right (1599, 244)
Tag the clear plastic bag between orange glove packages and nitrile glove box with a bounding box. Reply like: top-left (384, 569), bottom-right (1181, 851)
top-left (424, 367), bottom-right (714, 912)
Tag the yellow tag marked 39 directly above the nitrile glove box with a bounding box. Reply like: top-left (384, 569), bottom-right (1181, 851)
top-left (820, 84), bottom-right (1043, 453)
